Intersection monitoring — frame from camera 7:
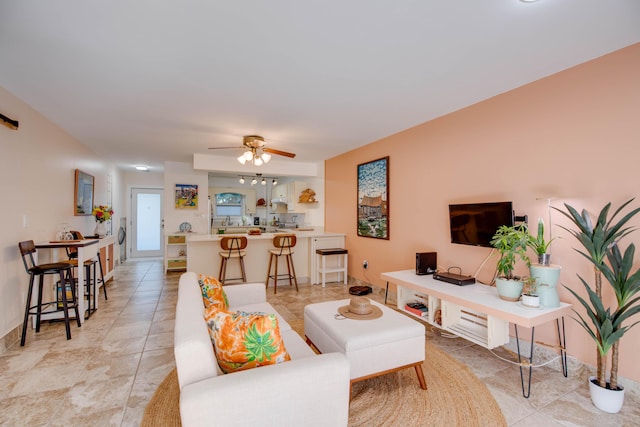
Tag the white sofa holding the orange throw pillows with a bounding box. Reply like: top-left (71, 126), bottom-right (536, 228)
top-left (174, 272), bottom-right (350, 427)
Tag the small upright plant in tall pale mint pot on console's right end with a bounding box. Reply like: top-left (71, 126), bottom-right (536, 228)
top-left (527, 218), bottom-right (562, 308)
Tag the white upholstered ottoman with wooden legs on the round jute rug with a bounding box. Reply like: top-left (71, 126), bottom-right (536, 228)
top-left (304, 299), bottom-right (427, 390)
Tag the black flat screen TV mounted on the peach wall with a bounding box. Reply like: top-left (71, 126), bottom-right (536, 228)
top-left (449, 202), bottom-right (514, 248)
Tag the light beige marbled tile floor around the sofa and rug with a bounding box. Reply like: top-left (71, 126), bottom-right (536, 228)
top-left (0, 259), bottom-right (640, 427)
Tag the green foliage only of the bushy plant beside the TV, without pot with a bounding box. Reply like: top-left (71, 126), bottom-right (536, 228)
top-left (491, 224), bottom-right (531, 280)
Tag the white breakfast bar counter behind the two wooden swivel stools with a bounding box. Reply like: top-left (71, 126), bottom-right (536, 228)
top-left (187, 229), bottom-right (345, 283)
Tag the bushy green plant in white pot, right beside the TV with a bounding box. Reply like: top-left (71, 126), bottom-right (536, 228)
top-left (491, 224), bottom-right (531, 301)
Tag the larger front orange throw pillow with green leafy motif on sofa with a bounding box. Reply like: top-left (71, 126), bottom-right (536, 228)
top-left (205, 306), bottom-right (291, 374)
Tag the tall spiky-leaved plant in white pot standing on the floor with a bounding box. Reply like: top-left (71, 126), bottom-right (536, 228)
top-left (556, 199), bottom-right (640, 413)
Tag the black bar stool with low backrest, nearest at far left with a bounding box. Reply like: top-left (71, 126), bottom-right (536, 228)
top-left (18, 240), bottom-right (81, 347)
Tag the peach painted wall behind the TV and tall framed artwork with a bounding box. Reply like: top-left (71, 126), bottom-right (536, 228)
top-left (325, 44), bottom-right (640, 381)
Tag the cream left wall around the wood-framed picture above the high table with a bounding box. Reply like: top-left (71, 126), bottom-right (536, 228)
top-left (0, 87), bottom-right (123, 351)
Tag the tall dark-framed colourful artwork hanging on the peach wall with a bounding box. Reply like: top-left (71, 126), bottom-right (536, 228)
top-left (358, 156), bottom-right (389, 240)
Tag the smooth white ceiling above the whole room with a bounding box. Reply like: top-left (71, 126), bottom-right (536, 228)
top-left (0, 0), bottom-right (640, 172)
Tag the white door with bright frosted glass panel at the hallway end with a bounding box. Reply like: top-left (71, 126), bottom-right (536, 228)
top-left (131, 188), bottom-right (164, 258)
